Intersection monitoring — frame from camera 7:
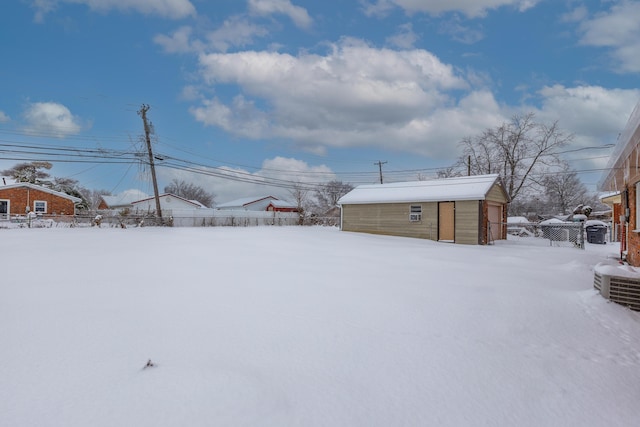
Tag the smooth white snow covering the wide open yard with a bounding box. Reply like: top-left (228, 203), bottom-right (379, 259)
top-left (0, 227), bottom-right (640, 427)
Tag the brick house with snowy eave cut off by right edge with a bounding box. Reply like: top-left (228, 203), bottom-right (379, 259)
top-left (599, 102), bottom-right (640, 267)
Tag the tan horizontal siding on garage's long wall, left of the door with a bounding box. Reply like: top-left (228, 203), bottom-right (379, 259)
top-left (342, 202), bottom-right (438, 240)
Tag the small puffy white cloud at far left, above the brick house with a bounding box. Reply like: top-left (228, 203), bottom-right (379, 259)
top-left (23, 102), bottom-right (82, 138)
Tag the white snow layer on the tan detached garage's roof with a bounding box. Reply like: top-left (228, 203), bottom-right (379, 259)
top-left (338, 174), bottom-right (499, 205)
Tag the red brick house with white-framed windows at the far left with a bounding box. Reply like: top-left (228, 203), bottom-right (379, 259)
top-left (0, 182), bottom-right (82, 220)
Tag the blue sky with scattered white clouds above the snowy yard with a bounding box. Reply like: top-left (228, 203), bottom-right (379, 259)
top-left (0, 0), bottom-right (640, 203)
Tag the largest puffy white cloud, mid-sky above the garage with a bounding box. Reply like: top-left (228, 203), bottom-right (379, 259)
top-left (191, 39), bottom-right (476, 159)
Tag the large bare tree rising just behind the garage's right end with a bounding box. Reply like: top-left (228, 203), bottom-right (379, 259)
top-left (459, 113), bottom-right (573, 200)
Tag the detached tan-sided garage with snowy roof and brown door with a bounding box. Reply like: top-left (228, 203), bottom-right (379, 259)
top-left (338, 174), bottom-right (509, 245)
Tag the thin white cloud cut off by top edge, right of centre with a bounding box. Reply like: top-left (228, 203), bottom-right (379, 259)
top-left (363, 0), bottom-right (539, 18)
